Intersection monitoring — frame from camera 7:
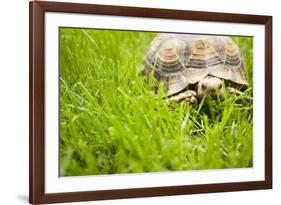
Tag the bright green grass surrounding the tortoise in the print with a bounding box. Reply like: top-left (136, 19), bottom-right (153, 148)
top-left (60, 28), bottom-right (253, 176)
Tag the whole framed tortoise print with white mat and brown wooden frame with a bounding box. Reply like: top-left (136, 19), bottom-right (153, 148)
top-left (30, 1), bottom-right (272, 204)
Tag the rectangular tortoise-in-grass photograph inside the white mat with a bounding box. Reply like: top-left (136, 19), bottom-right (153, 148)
top-left (58, 27), bottom-right (254, 177)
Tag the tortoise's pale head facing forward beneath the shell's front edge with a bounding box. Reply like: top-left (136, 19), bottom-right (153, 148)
top-left (197, 76), bottom-right (223, 97)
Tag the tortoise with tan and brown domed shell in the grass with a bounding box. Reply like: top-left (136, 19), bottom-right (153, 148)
top-left (145, 33), bottom-right (247, 103)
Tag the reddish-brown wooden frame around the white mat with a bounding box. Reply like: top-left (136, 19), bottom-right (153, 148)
top-left (29, 1), bottom-right (272, 204)
